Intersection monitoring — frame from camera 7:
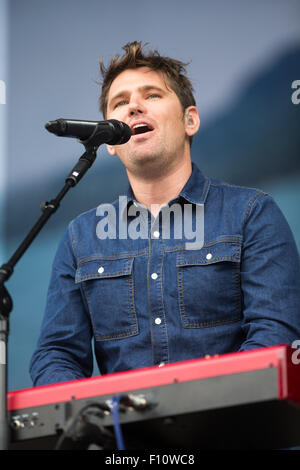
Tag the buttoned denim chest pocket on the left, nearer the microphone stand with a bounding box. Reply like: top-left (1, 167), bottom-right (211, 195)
top-left (75, 258), bottom-right (138, 341)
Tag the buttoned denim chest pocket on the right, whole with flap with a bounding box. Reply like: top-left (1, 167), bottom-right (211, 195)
top-left (177, 241), bottom-right (241, 328)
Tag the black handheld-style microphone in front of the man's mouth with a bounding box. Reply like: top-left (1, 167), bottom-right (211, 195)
top-left (45, 119), bottom-right (131, 145)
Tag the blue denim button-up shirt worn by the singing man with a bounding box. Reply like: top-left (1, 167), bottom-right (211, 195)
top-left (30, 164), bottom-right (300, 385)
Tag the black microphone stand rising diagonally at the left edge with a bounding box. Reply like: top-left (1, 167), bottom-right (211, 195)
top-left (0, 133), bottom-right (104, 450)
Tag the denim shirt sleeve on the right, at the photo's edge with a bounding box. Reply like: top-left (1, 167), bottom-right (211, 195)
top-left (240, 193), bottom-right (300, 350)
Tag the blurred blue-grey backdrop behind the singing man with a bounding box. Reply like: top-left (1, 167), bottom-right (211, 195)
top-left (0, 0), bottom-right (300, 390)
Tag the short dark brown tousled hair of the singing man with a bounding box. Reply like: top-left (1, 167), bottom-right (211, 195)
top-left (99, 41), bottom-right (196, 142)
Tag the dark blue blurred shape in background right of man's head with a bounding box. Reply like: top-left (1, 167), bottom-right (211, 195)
top-left (192, 43), bottom-right (300, 186)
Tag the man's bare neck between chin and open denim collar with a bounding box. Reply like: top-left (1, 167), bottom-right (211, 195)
top-left (127, 160), bottom-right (192, 216)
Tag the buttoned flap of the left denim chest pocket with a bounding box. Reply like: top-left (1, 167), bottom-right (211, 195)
top-left (75, 258), bottom-right (134, 283)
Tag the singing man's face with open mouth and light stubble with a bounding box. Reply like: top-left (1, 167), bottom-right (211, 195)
top-left (107, 67), bottom-right (199, 177)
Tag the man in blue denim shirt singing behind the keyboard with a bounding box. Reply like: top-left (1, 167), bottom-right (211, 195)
top-left (30, 42), bottom-right (300, 385)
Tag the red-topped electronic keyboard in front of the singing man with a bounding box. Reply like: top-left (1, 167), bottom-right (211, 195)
top-left (8, 346), bottom-right (300, 449)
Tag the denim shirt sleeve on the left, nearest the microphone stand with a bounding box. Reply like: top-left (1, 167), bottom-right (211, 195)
top-left (30, 225), bottom-right (93, 386)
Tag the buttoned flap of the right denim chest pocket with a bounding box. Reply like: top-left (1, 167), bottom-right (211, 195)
top-left (176, 241), bottom-right (241, 267)
